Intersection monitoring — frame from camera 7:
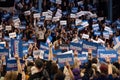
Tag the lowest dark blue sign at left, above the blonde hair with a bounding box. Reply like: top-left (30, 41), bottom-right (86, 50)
top-left (6, 59), bottom-right (24, 71)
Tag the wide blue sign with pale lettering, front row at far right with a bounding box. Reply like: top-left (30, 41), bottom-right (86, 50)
top-left (99, 50), bottom-right (118, 62)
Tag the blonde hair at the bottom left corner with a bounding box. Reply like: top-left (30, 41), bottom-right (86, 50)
top-left (4, 71), bottom-right (18, 80)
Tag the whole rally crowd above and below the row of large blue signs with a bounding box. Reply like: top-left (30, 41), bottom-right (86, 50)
top-left (0, 0), bottom-right (120, 80)
